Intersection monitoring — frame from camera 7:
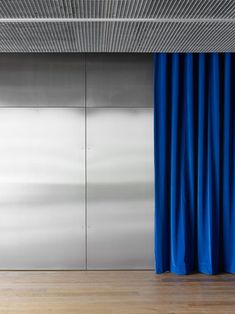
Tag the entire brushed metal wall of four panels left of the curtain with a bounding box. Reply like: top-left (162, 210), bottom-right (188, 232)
top-left (0, 54), bottom-right (154, 269)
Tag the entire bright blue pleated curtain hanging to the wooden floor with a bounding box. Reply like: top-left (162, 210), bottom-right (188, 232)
top-left (154, 53), bottom-right (235, 274)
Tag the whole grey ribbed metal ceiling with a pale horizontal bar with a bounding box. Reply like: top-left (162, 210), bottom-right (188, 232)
top-left (0, 0), bottom-right (235, 52)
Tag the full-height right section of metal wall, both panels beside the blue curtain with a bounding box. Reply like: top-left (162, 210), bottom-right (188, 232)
top-left (86, 54), bottom-right (154, 269)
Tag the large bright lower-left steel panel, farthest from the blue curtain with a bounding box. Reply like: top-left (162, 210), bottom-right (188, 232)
top-left (0, 108), bottom-right (85, 269)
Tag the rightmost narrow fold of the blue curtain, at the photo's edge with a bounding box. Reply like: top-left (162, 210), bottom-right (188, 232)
top-left (221, 54), bottom-right (235, 273)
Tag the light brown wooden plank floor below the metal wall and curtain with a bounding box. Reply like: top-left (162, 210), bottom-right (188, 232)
top-left (0, 271), bottom-right (235, 314)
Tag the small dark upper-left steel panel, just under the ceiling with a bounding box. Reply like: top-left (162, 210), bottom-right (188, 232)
top-left (0, 54), bottom-right (85, 107)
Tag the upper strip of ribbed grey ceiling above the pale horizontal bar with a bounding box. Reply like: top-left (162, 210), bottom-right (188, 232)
top-left (0, 0), bottom-right (235, 19)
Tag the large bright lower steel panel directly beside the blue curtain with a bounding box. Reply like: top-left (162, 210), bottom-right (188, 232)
top-left (87, 108), bottom-right (154, 269)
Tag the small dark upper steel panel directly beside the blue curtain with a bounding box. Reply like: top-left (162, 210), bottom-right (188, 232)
top-left (86, 54), bottom-right (154, 108)
